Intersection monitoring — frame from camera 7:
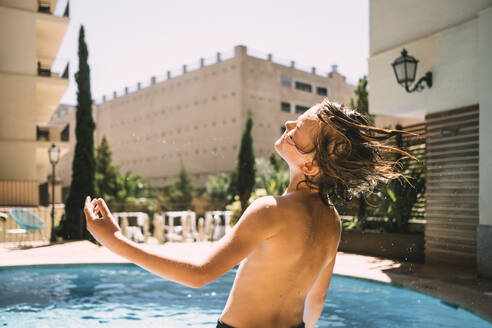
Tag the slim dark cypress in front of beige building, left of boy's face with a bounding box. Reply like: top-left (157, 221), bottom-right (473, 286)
top-left (237, 113), bottom-right (256, 212)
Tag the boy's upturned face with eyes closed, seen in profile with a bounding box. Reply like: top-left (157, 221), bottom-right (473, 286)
top-left (275, 104), bottom-right (320, 171)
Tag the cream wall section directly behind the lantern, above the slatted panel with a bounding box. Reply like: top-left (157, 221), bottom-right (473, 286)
top-left (369, 19), bottom-right (480, 118)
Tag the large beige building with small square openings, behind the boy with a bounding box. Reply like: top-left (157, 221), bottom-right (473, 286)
top-left (53, 46), bottom-right (354, 187)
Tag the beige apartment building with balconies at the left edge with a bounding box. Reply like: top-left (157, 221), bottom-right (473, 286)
top-left (0, 0), bottom-right (69, 206)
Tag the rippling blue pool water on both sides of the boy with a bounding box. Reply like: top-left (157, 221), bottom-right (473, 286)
top-left (0, 264), bottom-right (492, 328)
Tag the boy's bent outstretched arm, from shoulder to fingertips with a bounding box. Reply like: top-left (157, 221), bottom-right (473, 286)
top-left (84, 197), bottom-right (275, 288)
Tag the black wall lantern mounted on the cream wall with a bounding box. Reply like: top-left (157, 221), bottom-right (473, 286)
top-left (391, 49), bottom-right (432, 92)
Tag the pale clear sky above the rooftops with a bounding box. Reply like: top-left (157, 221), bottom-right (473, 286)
top-left (58, 0), bottom-right (369, 104)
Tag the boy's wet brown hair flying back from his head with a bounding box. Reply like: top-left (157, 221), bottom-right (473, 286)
top-left (299, 98), bottom-right (412, 205)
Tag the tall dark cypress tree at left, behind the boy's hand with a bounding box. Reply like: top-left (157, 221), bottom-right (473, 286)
top-left (59, 26), bottom-right (96, 241)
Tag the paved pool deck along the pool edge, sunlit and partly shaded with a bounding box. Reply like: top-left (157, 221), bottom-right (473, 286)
top-left (0, 241), bottom-right (492, 322)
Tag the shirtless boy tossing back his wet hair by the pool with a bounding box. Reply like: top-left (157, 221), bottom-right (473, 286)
top-left (84, 100), bottom-right (404, 328)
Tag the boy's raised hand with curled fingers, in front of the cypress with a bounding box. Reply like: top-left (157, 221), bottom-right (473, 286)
top-left (84, 196), bottom-right (121, 246)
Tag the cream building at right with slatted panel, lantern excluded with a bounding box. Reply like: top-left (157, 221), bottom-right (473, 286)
top-left (369, 0), bottom-right (492, 278)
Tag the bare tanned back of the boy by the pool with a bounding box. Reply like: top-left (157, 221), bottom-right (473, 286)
top-left (221, 192), bottom-right (341, 327)
